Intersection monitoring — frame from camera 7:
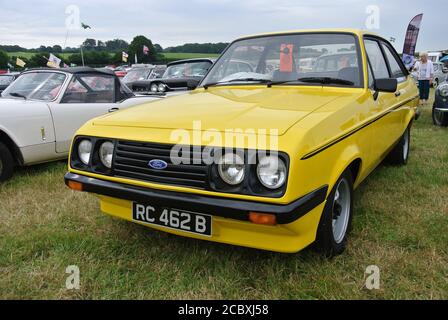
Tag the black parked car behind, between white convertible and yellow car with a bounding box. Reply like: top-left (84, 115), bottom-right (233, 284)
top-left (128, 58), bottom-right (215, 94)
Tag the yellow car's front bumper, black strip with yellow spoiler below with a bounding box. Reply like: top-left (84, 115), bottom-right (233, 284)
top-left (65, 173), bottom-right (328, 252)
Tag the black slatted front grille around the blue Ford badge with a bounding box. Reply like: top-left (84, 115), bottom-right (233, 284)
top-left (113, 141), bottom-right (208, 189)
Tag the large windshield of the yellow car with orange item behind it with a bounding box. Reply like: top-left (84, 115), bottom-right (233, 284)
top-left (201, 33), bottom-right (362, 87)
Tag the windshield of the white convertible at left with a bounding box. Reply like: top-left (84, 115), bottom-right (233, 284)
top-left (3, 72), bottom-right (66, 101)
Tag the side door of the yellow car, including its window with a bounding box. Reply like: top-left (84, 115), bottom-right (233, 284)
top-left (364, 38), bottom-right (407, 162)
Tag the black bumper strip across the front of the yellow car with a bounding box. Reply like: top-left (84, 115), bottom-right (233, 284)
top-left (65, 173), bottom-right (328, 224)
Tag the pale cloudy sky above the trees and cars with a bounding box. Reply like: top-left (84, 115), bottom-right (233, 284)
top-left (0, 0), bottom-right (448, 52)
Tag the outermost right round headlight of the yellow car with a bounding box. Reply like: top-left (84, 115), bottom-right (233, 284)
top-left (257, 156), bottom-right (286, 190)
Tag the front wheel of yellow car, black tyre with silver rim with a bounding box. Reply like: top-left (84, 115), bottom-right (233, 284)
top-left (316, 170), bottom-right (353, 257)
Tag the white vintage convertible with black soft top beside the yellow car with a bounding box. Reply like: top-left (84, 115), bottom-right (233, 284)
top-left (0, 67), bottom-right (160, 182)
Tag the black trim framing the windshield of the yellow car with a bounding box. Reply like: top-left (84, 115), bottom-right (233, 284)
top-left (201, 31), bottom-right (366, 89)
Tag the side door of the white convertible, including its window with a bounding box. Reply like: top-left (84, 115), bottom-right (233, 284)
top-left (50, 74), bottom-right (116, 153)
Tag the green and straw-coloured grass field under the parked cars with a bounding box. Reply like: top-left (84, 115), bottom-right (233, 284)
top-left (0, 94), bottom-right (448, 299)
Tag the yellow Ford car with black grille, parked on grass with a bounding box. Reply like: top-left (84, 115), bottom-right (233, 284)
top-left (65, 29), bottom-right (418, 256)
